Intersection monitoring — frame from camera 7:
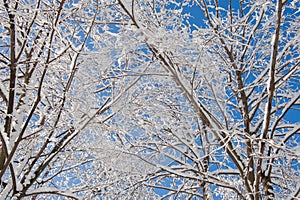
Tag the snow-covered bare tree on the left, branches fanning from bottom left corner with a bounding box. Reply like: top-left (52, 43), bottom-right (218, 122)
top-left (0, 0), bottom-right (158, 199)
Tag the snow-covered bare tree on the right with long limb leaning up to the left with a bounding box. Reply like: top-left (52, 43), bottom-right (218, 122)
top-left (108, 0), bottom-right (300, 199)
